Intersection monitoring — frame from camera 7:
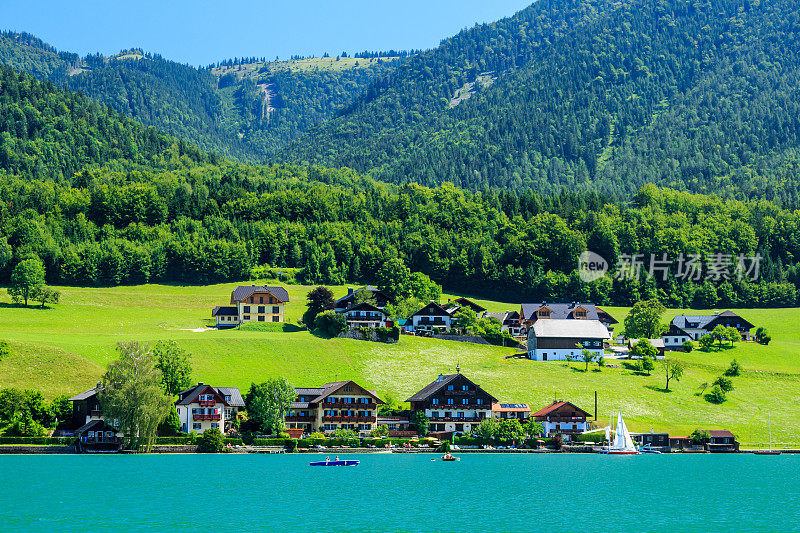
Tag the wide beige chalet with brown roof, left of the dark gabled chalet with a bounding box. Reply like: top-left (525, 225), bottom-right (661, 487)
top-left (285, 381), bottom-right (384, 435)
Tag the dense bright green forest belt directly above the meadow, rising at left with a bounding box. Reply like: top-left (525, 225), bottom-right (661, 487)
top-left (0, 67), bottom-right (800, 307)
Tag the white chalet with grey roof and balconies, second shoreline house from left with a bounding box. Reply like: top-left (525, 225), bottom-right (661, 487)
top-left (175, 383), bottom-right (244, 433)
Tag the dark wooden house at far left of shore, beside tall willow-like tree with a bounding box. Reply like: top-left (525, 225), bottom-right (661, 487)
top-left (69, 383), bottom-right (123, 453)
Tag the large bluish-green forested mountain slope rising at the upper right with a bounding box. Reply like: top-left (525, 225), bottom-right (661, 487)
top-left (281, 0), bottom-right (800, 204)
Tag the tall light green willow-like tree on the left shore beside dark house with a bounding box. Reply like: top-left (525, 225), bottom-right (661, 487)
top-left (99, 341), bottom-right (175, 452)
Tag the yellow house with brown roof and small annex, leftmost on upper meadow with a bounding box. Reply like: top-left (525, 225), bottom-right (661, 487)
top-left (211, 285), bottom-right (289, 328)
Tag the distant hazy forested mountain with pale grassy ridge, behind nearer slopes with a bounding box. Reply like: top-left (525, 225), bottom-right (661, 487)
top-left (0, 32), bottom-right (402, 162)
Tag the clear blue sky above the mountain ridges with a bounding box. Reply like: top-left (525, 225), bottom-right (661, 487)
top-left (0, 0), bottom-right (533, 65)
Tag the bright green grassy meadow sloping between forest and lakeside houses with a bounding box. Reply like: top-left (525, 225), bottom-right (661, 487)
top-left (0, 284), bottom-right (800, 443)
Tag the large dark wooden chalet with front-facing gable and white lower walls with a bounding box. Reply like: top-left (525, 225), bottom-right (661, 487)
top-left (406, 371), bottom-right (498, 433)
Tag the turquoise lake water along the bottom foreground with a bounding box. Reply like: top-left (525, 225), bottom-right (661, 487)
top-left (0, 454), bottom-right (800, 532)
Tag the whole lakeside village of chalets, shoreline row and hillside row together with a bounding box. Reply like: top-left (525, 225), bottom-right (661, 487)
top-left (7, 286), bottom-right (754, 453)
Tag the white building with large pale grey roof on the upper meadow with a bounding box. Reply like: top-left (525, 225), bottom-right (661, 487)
top-left (528, 318), bottom-right (611, 361)
